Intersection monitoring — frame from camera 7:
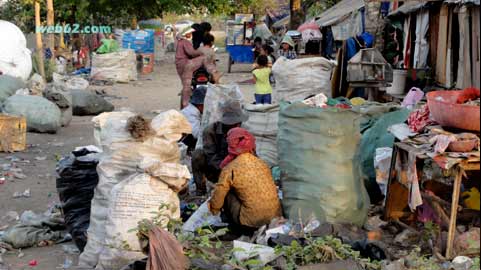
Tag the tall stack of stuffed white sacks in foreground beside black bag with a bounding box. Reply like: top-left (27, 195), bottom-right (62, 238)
top-left (79, 110), bottom-right (191, 269)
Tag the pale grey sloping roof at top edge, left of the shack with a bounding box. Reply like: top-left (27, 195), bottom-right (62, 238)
top-left (316, 0), bottom-right (364, 27)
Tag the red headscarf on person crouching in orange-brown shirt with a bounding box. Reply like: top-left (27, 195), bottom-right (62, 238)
top-left (220, 128), bottom-right (256, 168)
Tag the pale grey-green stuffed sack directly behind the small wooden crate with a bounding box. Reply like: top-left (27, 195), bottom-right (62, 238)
top-left (3, 95), bottom-right (61, 133)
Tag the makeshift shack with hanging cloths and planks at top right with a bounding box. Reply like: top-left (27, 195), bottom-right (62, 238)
top-left (384, 0), bottom-right (480, 93)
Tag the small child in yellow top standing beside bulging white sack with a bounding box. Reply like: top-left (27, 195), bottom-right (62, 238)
top-left (252, 55), bottom-right (272, 104)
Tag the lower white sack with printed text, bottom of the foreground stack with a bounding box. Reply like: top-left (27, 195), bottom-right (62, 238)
top-left (96, 174), bottom-right (180, 270)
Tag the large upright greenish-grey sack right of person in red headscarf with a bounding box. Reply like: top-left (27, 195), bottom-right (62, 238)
top-left (277, 102), bottom-right (370, 225)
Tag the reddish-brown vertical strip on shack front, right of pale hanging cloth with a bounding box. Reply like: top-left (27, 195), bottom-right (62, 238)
top-left (436, 5), bottom-right (449, 85)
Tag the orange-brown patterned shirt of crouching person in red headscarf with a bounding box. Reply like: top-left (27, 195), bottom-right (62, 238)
top-left (209, 153), bottom-right (282, 228)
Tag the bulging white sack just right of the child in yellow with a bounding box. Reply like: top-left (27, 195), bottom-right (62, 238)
top-left (272, 57), bottom-right (336, 102)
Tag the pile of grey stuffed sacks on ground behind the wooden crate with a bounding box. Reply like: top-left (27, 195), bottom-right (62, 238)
top-left (0, 73), bottom-right (114, 133)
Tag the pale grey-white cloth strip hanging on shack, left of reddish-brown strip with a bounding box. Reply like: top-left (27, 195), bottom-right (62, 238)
top-left (413, 10), bottom-right (429, 68)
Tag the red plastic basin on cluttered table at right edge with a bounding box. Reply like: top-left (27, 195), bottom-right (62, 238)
top-left (427, 91), bottom-right (480, 131)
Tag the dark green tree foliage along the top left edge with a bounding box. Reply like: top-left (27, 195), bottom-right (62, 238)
top-left (0, 0), bottom-right (238, 31)
